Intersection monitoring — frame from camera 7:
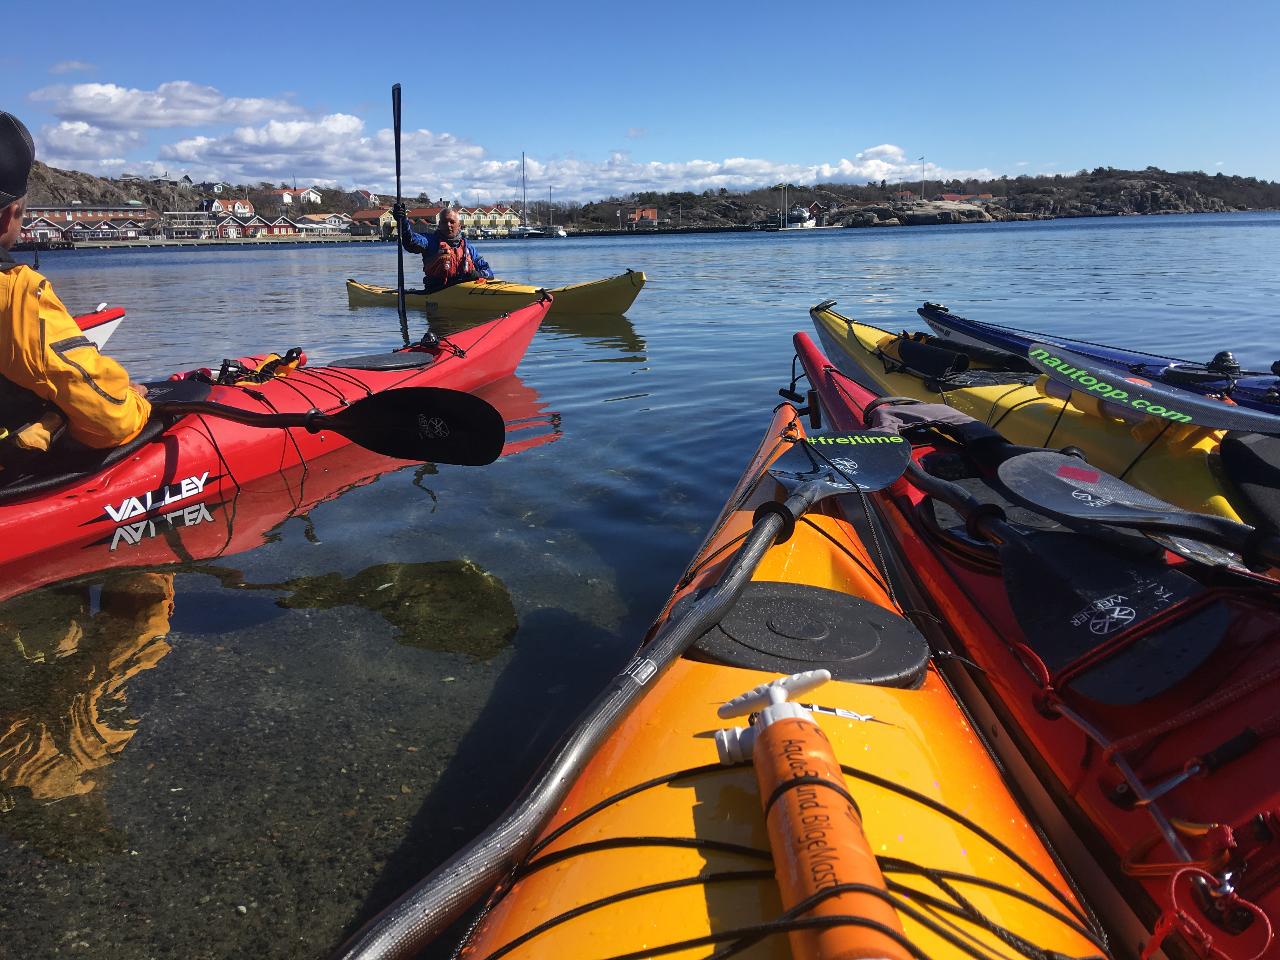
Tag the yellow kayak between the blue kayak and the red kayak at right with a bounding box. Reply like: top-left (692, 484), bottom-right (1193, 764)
top-left (809, 301), bottom-right (1251, 520)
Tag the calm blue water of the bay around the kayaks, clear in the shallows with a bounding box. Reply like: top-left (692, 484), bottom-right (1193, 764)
top-left (0, 215), bottom-right (1280, 959)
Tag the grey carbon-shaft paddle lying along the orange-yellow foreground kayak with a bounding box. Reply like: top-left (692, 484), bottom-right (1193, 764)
top-left (335, 434), bottom-right (911, 960)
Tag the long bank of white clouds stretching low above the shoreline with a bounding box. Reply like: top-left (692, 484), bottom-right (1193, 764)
top-left (32, 81), bottom-right (992, 202)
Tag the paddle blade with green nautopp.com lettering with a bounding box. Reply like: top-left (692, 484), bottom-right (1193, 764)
top-left (1027, 343), bottom-right (1280, 434)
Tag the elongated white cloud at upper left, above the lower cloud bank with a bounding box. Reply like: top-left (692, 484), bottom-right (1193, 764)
top-left (31, 81), bottom-right (301, 129)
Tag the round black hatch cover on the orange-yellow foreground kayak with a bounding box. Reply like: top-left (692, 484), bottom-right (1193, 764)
top-left (691, 581), bottom-right (929, 687)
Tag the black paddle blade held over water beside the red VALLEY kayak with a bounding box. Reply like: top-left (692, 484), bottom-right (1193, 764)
top-left (317, 387), bottom-right (507, 466)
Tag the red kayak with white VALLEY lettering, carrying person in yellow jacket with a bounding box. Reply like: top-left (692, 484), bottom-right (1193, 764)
top-left (0, 301), bottom-right (549, 578)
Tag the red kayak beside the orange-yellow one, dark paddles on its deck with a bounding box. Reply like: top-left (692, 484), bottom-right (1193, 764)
top-left (792, 333), bottom-right (1280, 960)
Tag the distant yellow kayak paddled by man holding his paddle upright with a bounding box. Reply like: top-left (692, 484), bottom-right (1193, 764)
top-left (347, 270), bottom-right (645, 316)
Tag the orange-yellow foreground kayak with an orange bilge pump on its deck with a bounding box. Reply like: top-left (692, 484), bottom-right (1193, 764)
top-left (340, 404), bottom-right (1107, 960)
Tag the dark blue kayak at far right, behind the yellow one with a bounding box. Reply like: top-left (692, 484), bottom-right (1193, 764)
top-left (915, 303), bottom-right (1280, 413)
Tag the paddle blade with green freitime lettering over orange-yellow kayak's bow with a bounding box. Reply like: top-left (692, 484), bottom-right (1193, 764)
top-left (769, 430), bottom-right (911, 499)
